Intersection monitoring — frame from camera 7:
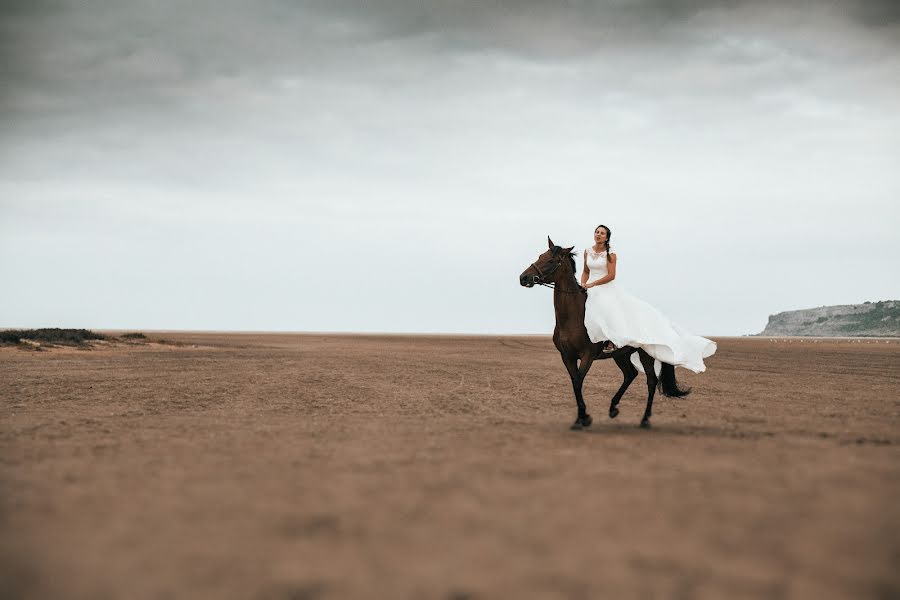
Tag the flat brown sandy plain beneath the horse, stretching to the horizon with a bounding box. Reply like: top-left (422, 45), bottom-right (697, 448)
top-left (0, 333), bottom-right (900, 600)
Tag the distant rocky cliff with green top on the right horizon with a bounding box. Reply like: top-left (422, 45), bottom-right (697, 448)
top-left (758, 300), bottom-right (900, 337)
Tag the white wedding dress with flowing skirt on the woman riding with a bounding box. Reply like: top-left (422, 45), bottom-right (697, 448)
top-left (584, 250), bottom-right (716, 373)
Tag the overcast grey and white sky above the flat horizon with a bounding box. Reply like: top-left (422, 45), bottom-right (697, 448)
top-left (0, 0), bottom-right (900, 335)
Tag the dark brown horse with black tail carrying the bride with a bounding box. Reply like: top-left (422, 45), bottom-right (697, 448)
top-left (519, 237), bottom-right (690, 429)
